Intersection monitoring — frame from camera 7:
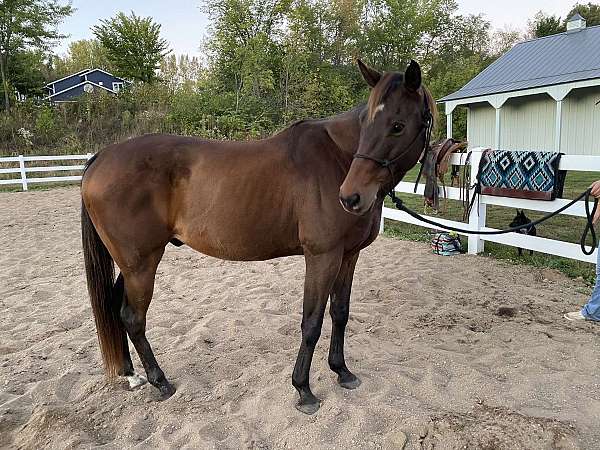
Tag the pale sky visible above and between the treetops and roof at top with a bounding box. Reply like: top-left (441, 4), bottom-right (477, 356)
top-left (56, 0), bottom-right (576, 56)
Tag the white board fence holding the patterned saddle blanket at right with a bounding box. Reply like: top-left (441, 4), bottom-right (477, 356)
top-left (382, 148), bottom-right (600, 263)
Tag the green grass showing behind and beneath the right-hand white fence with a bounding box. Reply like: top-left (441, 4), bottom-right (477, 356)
top-left (385, 165), bottom-right (600, 285)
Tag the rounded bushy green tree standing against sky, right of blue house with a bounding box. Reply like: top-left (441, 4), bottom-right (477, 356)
top-left (92, 12), bottom-right (170, 83)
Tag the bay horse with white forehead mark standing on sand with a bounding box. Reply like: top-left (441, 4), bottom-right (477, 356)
top-left (81, 60), bottom-right (435, 414)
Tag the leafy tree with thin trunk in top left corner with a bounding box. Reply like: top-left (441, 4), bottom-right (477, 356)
top-left (0, 0), bottom-right (73, 111)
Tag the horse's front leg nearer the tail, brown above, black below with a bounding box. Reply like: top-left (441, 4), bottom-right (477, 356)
top-left (292, 249), bottom-right (343, 414)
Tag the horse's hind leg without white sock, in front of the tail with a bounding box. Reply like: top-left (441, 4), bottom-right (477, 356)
top-left (121, 249), bottom-right (175, 398)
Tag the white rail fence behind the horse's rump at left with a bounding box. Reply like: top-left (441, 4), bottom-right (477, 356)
top-left (0, 153), bottom-right (92, 191)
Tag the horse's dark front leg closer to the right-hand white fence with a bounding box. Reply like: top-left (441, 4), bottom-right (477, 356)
top-left (329, 253), bottom-right (360, 389)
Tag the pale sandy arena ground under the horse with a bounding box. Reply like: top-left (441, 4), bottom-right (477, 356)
top-left (0, 188), bottom-right (600, 449)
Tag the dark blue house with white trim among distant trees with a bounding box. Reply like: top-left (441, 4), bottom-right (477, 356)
top-left (44, 69), bottom-right (131, 103)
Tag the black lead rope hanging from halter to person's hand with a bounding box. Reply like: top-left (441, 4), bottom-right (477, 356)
top-left (388, 188), bottom-right (598, 255)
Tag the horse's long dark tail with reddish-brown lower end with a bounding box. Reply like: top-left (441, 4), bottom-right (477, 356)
top-left (81, 195), bottom-right (125, 378)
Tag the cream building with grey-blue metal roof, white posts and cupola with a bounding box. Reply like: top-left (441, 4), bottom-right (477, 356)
top-left (439, 14), bottom-right (600, 155)
